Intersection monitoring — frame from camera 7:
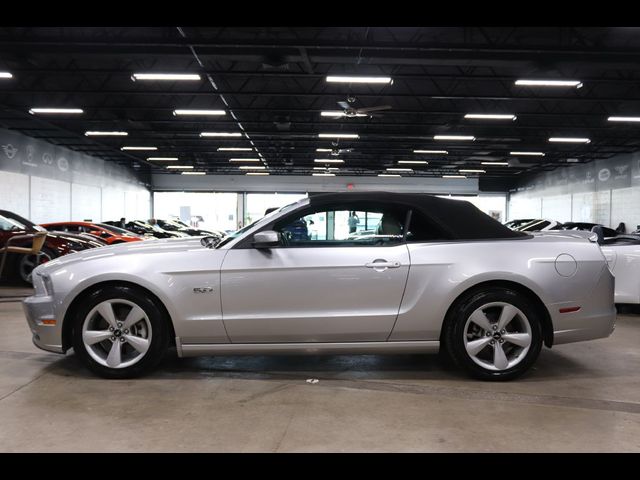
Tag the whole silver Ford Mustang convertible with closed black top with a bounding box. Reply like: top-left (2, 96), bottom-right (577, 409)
top-left (24, 192), bottom-right (615, 380)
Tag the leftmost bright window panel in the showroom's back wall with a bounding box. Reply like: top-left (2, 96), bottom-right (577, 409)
top-left (153, 192), bottom-right (241, 232)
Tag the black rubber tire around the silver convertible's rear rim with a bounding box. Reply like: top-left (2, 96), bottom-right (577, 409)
top-left (442, 287), bottom-right (543, 381)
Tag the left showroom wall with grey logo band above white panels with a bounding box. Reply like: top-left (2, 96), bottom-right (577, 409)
top-left (0, 129), bottom-right (151, 223)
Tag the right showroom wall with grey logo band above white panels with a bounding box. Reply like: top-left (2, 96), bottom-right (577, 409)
top-left (508, 152), bottom-right (640, 232)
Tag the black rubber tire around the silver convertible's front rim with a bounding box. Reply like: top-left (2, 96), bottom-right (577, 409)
top-left (71, 285), bottom-right (170, 379)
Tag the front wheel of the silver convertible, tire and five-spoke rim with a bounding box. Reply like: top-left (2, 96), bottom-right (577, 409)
top-left (73, 286), bottom-right (169, 378)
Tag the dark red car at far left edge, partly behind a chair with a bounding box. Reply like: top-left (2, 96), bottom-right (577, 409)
top-left (0, 210), bottom-right (105, 283)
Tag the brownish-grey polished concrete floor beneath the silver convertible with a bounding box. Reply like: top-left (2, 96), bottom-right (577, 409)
top-left (0, 302), bottom-right (640, 452)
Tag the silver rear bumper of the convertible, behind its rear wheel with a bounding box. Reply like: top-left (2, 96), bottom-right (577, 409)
top-left (547, 265), bottom-right (616, 345)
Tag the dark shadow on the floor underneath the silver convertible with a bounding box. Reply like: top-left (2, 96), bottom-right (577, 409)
top-left (41, 349), bottom-right (605, 382)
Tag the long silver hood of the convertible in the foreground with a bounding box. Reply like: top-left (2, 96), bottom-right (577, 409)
top-left (34, 237), bottom-right (206, 274)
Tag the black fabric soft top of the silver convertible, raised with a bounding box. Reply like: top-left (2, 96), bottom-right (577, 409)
top-left (309, 192), bottom-right (530, 240)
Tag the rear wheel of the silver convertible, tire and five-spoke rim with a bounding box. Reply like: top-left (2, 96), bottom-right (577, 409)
top-left (443, 288), bottom-right (542, 380)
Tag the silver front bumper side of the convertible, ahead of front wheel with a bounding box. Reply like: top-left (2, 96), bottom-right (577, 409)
top-left (22, 296), bottom-right (64, 353)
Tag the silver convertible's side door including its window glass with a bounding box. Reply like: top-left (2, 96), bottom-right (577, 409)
top-left (221, 202), bottom-right (409, 343)
